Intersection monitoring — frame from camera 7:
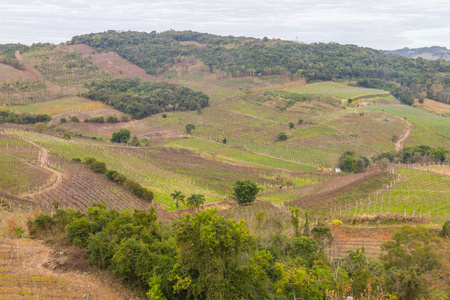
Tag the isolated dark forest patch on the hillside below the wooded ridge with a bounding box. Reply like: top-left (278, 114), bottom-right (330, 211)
top-left (85, 78), bottom-right (209, 119)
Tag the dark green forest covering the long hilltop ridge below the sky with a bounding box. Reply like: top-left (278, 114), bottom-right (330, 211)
top-left (70, 30), bottom-right (450, 104)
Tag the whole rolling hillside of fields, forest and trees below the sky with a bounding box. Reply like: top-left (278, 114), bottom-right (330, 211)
top-left (0, 31), bottom-right (450, 299)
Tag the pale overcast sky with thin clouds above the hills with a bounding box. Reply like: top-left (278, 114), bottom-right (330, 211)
top-left (0, 0), bottom-right (450, 50)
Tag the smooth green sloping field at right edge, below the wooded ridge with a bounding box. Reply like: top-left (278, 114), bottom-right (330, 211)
top-left (365, 105), bottom-right (450, 137)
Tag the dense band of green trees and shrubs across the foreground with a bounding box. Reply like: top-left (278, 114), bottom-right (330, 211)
top-left (28, 204), bottom-right (446, 300)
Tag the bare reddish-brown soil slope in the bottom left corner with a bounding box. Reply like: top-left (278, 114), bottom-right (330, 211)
top-left (0, 238), bottom-right (136, 299)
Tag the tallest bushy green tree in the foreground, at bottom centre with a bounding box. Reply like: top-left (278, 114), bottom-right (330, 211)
top-left (170, 210), bottom-right (273, 299)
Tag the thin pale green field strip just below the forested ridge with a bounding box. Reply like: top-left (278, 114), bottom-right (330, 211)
top-left (288, 82), bottom-right (389, 99)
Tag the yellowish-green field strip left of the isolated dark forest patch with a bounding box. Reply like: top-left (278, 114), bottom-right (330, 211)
top-left (9, 97), bottom-right (109, 116)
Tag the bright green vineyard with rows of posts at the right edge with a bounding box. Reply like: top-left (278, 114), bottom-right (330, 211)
top-left (348, 169), bottom-right (450, 222)
